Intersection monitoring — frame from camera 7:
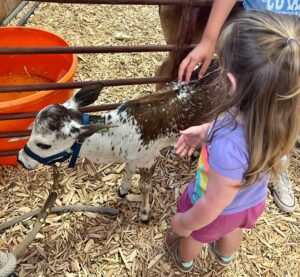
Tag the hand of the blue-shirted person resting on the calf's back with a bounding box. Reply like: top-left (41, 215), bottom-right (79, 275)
top-left (178, 38), bottom-right (216, 84)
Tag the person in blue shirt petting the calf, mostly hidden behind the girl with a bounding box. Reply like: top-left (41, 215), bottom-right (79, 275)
top-left (178, 0), bottom-right (300, 213)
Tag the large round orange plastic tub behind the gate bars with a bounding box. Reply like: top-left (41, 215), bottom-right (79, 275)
top-left (0, 27), bottom-right (77, 165)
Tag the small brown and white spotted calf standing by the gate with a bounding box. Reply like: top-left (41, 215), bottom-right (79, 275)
top-left (18, 59), bottom-right (220, 221)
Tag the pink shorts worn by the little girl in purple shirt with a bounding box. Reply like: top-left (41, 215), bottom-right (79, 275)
top-left (177, 185), bottom-right (266, 243)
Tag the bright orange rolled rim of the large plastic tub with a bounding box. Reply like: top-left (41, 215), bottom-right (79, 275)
top-left (0, 26), bottom-right (78, 113)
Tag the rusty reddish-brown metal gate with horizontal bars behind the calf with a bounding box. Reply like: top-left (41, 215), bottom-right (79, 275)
top-left (0, 0), bottom-right (240, 157)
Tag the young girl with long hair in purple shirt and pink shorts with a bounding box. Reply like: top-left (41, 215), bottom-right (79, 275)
top-left (166, 11), bottom-right (300, 272)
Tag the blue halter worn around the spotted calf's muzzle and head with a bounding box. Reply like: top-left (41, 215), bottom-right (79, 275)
top-left (23, 113), bottom-right (90, 168)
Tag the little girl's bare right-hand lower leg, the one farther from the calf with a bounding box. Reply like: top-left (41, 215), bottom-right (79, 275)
top-left (217, 228), bottom-right (243, 257)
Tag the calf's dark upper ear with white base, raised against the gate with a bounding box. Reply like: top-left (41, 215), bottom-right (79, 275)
top-left (64, 84), bottom-right (104, 110)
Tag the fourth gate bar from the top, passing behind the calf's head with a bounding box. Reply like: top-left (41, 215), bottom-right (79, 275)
top-left (0, 103), bottom-right (122, 120)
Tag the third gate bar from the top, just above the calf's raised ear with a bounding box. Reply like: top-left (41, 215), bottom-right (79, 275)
top-left (0, 76), bottom-right (172, 92)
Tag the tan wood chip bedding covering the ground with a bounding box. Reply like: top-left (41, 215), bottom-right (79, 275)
top-left (0, 4), bottom-right (300, 277)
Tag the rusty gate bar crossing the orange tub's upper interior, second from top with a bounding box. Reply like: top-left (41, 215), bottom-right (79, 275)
top-left (0, 44), bottom-right (196, 55)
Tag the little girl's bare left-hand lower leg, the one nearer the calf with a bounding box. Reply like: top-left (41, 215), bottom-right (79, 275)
top-left (178, 236), bottom-right (203, 262)
